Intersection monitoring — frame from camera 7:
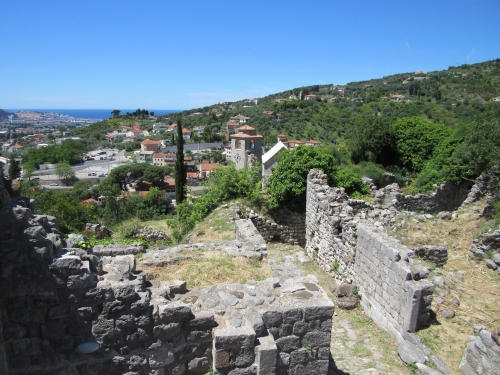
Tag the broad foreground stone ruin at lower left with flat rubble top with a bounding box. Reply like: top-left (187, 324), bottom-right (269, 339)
top-left (0, 171), bottom-right (334, 375)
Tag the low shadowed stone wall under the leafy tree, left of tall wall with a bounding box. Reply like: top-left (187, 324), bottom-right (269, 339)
top-left (238, 208), bottom-right (306, 246)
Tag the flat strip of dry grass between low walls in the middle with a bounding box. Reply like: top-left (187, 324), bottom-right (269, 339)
top-left (137, 250), bottom-right (271, 289)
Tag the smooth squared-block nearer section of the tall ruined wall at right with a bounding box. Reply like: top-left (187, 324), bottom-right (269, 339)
top-left (354, 225), bottom-right (434, 337)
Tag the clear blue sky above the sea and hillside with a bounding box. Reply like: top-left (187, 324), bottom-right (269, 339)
top-left (0, 0), bottom-right (500, 109)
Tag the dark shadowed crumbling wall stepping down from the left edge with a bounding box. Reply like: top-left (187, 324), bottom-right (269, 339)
top-left (0, 199), bottom-right (215, 374)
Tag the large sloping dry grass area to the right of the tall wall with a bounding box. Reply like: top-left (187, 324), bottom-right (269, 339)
top-left (390, 202), bottom-right (500, 374)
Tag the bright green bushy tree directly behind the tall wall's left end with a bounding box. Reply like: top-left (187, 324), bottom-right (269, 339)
top-left (267, 146), bottom-right (337, 211)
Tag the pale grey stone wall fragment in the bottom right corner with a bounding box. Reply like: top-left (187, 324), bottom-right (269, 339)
top-left (460, 328), bottom-right (500, 375)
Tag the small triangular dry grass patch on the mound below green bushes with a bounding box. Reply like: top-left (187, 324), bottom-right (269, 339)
top-left (190, 208), bottom-right (235, 242)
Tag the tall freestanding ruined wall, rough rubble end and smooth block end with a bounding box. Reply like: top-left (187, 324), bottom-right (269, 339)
top-left (305, 169), bottom-right (434, 338)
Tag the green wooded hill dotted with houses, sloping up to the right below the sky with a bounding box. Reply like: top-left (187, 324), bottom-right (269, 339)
top-left (162, 59), bottom-right (500, 145)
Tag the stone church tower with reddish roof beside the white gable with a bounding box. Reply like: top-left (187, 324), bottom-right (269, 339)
top-left (231, 125), bottom-right (262, 169)
